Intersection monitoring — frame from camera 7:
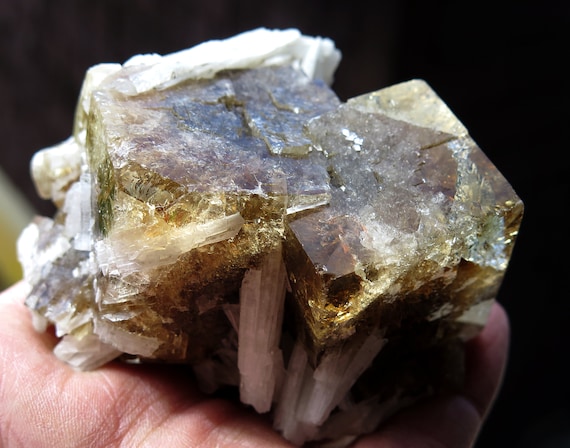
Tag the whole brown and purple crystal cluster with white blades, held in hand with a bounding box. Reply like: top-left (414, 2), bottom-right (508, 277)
top-left (19, 29), bottom-right (523, 446)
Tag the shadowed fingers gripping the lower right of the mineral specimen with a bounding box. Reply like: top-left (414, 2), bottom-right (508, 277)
top-left (355, 304), bottom-right (509, 448)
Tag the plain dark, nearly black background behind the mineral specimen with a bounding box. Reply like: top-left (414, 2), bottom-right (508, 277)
top-left (0, 0), bottom-right (570, 448)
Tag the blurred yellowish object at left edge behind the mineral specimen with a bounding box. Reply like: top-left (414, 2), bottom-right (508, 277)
top-left (0, 169), bottom-right (34, 289)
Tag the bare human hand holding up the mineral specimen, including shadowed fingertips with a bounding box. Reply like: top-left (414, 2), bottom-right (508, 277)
top-left (0, 283), bottom-right (509, 448)
